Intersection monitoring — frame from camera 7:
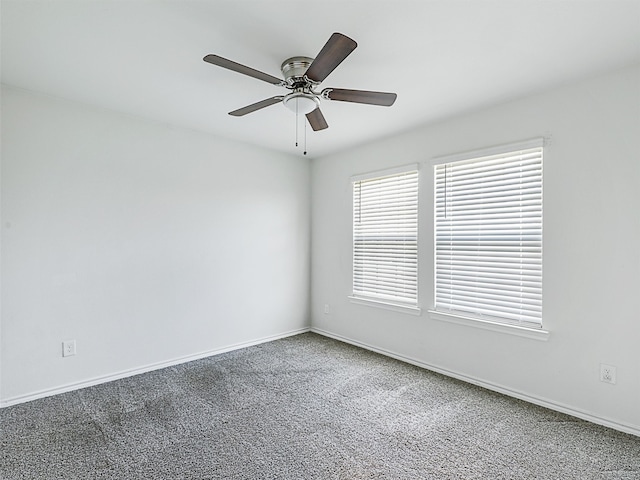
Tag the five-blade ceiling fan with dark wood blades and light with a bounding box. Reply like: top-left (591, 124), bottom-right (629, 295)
top-left (203, 33), bottom-right (397, 131)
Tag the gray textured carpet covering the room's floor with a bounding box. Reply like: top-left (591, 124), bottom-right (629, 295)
top-left (0, 333), bottom-right (640, 480)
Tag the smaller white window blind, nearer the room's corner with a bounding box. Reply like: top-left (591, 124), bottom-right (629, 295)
top-left (353, 169), bottom-right (418, 305)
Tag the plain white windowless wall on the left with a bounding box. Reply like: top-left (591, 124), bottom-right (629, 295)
top-left (0, 86), bottom-right (310, 404)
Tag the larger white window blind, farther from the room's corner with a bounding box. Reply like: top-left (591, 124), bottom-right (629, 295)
top-left (434, 147), bottom-right (542, 327)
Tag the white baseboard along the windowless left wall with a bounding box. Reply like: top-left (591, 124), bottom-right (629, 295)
top-left (0, 327), bottom-right (311, 408)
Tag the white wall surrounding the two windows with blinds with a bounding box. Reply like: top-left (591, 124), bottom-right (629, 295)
top-left (311, 64), bottom-right (640, 434)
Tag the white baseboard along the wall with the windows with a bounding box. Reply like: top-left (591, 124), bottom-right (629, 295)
top-left (311, 327), bottom-right (640, 437)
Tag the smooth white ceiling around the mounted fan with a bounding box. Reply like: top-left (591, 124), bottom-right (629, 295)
top-left (0, 0), bottom-right (640, 157)
